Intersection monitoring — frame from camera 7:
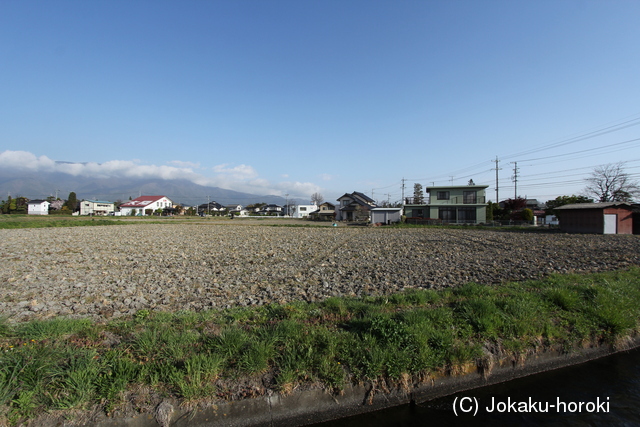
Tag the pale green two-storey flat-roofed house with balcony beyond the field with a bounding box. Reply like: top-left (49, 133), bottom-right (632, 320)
top-left (404, 185), bottom-right (489, 224)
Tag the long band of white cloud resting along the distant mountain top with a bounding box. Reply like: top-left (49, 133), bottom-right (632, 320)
top-left (0, 151), bottom-right (322, 198)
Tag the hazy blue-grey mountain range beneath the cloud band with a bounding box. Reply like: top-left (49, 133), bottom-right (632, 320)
top-left (0, 171), bottom-right (292, 206)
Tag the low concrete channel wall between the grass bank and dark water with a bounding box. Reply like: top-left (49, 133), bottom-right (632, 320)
top-left (86, 337), bottom-right (640, 427)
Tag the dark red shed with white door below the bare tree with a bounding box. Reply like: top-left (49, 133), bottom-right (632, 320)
top-left (556, 202), bottom-right (633, 234)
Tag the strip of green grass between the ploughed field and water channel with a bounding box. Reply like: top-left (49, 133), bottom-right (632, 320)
top-left (0, 267), bottom-right (640, 424)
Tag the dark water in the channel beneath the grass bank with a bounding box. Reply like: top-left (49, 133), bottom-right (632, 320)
top-left (316, 349), bottom-right (640, 427)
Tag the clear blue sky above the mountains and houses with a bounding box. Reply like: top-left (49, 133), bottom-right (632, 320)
top-left (0, 0), bottom-right (640, 201)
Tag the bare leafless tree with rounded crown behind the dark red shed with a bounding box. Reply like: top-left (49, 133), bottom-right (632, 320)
top-left (584, 162), bottom-right (640, 202)
